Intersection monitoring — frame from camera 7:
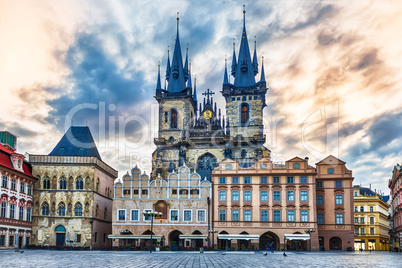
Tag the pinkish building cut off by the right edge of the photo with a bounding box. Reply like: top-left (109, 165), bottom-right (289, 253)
top-left (388, 164), bottom-right (402, 251)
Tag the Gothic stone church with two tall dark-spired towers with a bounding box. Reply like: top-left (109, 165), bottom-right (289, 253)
top-left (151, 6), bottom-right (270, 180)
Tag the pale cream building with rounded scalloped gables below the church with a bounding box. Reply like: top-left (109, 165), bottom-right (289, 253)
top-left (109, 166), bottom-right (211, 250)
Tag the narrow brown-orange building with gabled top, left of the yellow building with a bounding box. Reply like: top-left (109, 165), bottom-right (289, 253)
top-left (316, 155), bottom-right (354, 250)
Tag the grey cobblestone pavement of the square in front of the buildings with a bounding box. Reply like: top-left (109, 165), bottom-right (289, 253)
top-left (0, 250), bottom-right (402, 268)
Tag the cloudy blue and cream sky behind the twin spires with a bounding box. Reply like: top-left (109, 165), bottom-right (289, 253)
top-left (0, 0), bottom-right (402, 192)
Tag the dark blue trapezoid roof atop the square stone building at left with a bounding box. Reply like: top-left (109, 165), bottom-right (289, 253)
top-left (49, 126), bottom-right (102, 160)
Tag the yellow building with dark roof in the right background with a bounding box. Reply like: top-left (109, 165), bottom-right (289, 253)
top-left (353, 186), bottom-right (390, 250)
